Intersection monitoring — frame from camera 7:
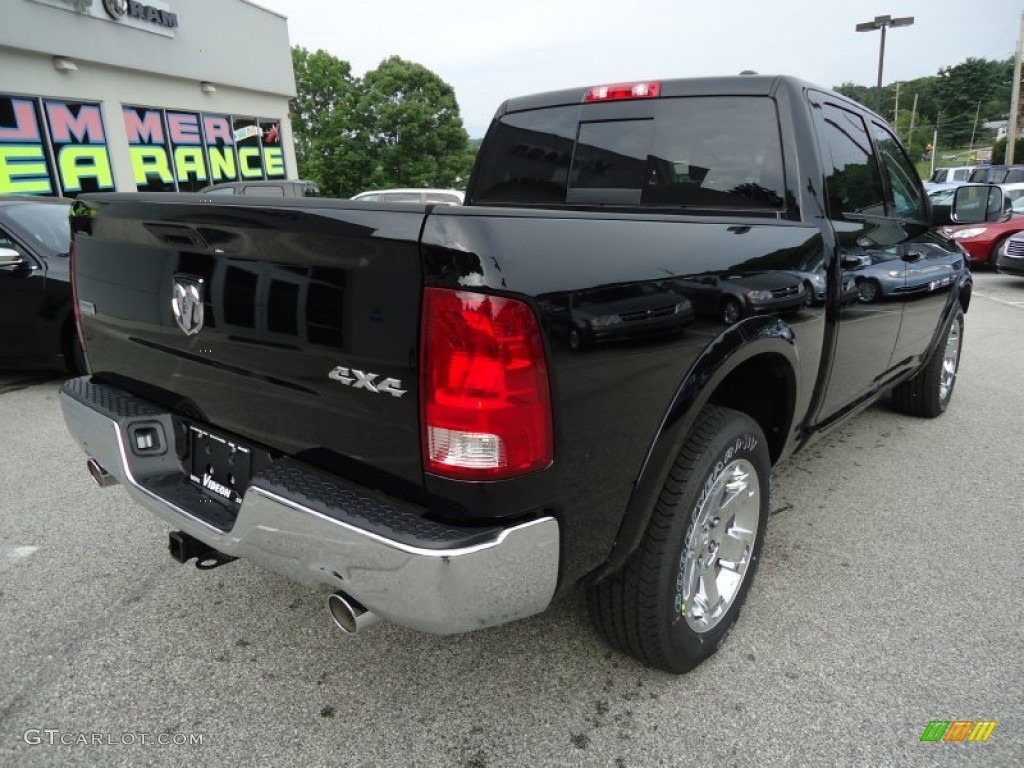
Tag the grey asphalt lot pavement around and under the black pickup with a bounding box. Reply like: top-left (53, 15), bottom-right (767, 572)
top-left (0, 272), bottom-right (1024, 768)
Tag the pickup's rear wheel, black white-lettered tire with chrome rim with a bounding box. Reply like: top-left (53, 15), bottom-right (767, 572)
top-left (587, 407), bottom-right (771, 673)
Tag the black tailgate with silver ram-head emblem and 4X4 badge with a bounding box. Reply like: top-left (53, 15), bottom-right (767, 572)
top-left (75, 195), bottom-right (425, 483)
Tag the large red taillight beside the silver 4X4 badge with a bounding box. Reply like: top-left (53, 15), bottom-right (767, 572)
top-left (420, 288), bottom-right (553, 480)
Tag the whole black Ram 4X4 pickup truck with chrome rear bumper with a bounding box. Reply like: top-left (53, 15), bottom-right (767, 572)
top-left (60, 76), bottom-right (1004, 672)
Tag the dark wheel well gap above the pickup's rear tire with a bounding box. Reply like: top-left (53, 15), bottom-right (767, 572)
top-left (708, 354), bottom-right (796, 464)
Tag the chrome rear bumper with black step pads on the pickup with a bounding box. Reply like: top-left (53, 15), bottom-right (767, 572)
top-left (60, 377), bottom-right (559, 635)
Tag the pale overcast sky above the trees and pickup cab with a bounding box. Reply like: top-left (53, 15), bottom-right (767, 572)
top-left (255, 0), bottom-right (1024, 137)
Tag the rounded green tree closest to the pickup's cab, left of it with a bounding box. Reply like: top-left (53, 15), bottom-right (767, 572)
top-left (356, 56), bottom-right (474, 187)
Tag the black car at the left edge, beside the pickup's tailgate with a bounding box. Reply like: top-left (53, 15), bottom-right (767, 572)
top-left (0, 196), bottom-right (79, 371)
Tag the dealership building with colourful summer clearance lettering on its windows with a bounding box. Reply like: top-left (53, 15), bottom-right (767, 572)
top-left (0, 0), bottom-right (296, 196)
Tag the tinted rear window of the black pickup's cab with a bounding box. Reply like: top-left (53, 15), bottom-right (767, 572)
top-left (475, 96), bottom-right (785, 210)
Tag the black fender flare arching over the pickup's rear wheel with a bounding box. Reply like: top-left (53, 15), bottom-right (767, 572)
top-left (586, 316), bottom-right (800, 584)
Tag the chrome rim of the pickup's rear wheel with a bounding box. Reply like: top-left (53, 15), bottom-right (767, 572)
top-left (677, 459), bottom-right (761, 633)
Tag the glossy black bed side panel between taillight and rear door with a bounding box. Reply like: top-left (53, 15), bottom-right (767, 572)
top-left (423, 207), bottom-right (825, 583)
